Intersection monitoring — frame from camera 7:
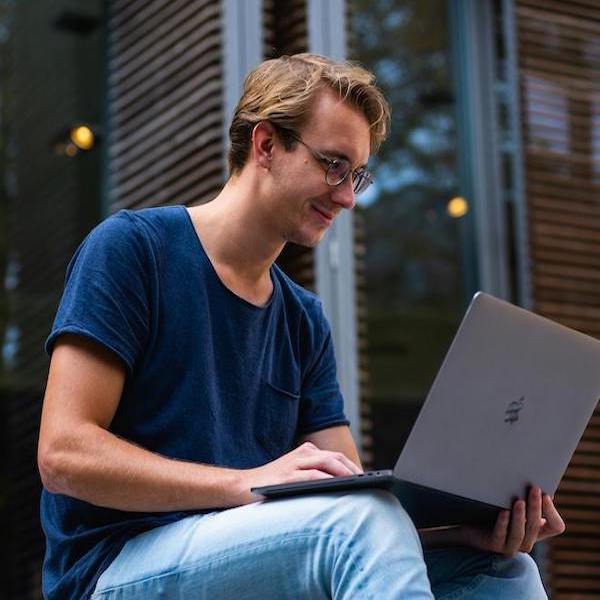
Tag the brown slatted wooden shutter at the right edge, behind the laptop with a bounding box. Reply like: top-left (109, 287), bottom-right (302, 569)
top-left (516, 0), bottom-right (600, 600)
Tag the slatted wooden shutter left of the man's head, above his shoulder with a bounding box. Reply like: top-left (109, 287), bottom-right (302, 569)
top-left (108, 0), bottom-right (224, 212)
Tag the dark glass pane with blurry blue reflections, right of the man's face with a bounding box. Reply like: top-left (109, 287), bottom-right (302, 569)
top-left (352, 0), bottom-right (468, 467)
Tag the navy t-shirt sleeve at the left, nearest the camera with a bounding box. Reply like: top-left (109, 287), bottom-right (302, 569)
top-left (45, 211), bottom-right (150, 374)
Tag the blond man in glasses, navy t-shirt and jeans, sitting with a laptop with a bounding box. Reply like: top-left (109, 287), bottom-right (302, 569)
top-left (39, 55), bottom-right (564, 599)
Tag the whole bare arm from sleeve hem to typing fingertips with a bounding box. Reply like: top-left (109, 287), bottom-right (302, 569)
top-left (38, 335), bottom-right (356, 512)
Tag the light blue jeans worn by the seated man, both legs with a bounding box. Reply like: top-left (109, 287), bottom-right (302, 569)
top-left (92, 490), bottom-right (546, 600)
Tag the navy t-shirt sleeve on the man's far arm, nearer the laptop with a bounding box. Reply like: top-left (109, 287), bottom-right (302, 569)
top-left (298, 302), bottom-right (350, 434)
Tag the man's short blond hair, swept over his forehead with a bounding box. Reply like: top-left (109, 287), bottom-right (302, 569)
top-left (228, 53), bottom-right (390, 175)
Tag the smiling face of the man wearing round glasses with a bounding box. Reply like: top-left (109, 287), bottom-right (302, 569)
top-left (273, 92), bottom-right (370, 246)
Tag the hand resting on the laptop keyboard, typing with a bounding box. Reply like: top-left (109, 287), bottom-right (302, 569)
top-left (240, 442), bottom-right (363, 504)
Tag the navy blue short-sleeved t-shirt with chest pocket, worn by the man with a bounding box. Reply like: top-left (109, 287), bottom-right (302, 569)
top-left (41, 206), bottom-right (348, 600)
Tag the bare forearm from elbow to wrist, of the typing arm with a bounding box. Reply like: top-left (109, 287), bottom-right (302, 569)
top-left (40, 425), bottom-right (253, 512)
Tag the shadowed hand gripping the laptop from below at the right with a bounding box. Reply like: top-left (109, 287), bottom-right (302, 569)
top-left (460, 487), bottom-right (565, 557)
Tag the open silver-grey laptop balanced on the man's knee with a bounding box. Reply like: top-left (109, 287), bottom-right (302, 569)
top-left (252, 292), bottom-right (600, 527)
